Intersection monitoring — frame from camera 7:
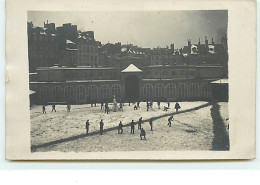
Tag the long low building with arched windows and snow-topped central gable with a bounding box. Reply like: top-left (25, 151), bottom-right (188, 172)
top-left (30, 64), bottom-right (223, 104)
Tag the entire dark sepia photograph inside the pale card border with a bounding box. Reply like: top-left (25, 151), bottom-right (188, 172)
top-left (27, 10), bottom-right (230, 153)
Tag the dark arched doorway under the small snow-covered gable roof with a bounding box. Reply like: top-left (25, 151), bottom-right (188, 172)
top-left (125, 75), bottom-right (139, 100)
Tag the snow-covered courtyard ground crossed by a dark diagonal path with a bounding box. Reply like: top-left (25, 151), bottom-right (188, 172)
top-left (31, 102), bottom-right (228, 152)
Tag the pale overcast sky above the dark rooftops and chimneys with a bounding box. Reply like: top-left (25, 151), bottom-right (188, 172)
top-left (28, 10), bottom-right (228, 48)
